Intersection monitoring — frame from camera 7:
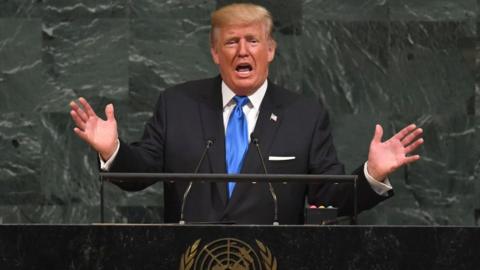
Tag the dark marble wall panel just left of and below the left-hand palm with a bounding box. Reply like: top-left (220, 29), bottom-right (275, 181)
top-left (40, 112), bottom-right (100, 205)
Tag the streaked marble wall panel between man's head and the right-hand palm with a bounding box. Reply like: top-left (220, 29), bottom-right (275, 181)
top-left (296, 20), bottom-right (389, 117)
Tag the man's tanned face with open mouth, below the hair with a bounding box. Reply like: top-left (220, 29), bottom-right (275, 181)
top-left (210, 23), bottom-right (275, 96)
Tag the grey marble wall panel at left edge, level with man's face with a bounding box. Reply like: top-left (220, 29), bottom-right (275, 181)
top-left (0, 18), bottom-right (50, 113)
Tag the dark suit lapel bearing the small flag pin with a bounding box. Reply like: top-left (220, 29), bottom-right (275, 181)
top-left (229, 82), bottom-right (283, 206)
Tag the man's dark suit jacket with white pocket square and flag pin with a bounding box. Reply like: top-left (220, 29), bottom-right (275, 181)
top-left (111, 77), bottom-right (391, 224)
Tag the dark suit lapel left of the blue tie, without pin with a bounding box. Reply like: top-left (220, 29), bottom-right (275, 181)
top-left (199, 77), bottom-right (227, 205)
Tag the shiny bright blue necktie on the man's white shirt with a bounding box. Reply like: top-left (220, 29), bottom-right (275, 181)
top-left (225, 96), bottom-right (249, 198)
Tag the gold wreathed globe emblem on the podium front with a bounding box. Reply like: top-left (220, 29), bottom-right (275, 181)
top-left (180, 238), bottom-right (277, 270)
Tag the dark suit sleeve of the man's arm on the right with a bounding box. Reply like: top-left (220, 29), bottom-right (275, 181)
top-left (307, 104), bottom-right (393, 216)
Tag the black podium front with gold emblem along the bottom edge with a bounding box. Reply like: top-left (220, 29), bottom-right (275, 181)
top-left (0, 224), bottom-right (480, 270)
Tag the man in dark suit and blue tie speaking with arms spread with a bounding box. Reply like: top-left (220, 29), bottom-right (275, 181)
top-left (70, 4), bottom-right (423, 224)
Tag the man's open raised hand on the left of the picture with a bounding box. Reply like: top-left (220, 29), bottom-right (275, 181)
top-left (70, 97), bottom-right (118, 161)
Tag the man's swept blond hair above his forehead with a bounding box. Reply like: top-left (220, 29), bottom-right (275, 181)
top-left (210, 3), bottom-right (273, 46)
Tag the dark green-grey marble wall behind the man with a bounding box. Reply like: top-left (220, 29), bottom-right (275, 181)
top-left (0, 0), bottom-right (480, 225)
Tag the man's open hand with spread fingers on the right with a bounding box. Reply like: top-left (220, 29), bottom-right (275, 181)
top-left (367, 124), bottom-right (423, 182)
